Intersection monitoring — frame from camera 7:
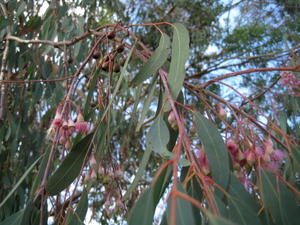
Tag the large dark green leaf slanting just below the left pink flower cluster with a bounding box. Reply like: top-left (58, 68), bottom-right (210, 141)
top-left (47, 133), bottom-right (94, 196)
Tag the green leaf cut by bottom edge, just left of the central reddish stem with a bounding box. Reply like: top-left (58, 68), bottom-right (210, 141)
top-left (128, 166), bottom-right (172, 225)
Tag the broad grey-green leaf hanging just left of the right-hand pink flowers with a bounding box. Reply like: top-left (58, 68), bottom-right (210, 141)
top-left (194, 112), bottom-right (230, 188)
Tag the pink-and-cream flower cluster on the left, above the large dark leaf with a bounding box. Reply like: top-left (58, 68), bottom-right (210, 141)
top-left (47, 107), bottom-right (91, 149)
